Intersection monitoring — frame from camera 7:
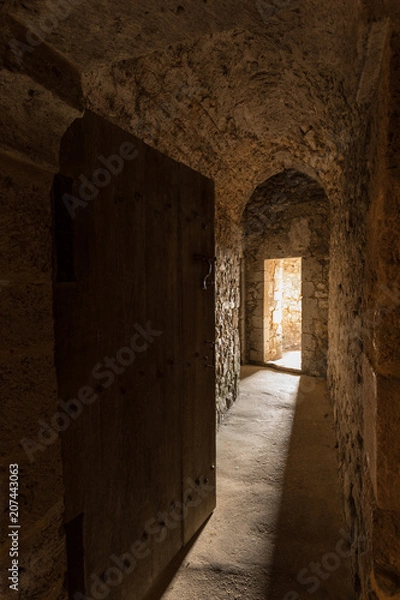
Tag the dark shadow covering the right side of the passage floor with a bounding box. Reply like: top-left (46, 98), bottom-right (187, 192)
top-left (265, 376), bottom-right (355, 600)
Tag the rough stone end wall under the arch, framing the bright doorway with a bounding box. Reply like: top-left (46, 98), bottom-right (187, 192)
top-left (244, 170), bottom-right (330, 376)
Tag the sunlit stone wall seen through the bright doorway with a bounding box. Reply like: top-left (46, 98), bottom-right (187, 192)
top-left (282, 259), bottom-right (300, 350)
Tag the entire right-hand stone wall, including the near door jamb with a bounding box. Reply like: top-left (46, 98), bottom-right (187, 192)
top-left (329, 15), bottom-right (400, 600)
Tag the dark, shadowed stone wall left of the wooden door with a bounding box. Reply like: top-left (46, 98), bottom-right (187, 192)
top-left (0, 81), bottom-right (80, 600)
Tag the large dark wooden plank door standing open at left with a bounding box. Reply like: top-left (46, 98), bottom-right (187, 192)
top-left (53, 112), bottom-right (215, 600)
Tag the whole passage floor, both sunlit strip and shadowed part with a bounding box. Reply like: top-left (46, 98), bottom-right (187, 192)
top-left (162, 367), bottom-right (354, 600)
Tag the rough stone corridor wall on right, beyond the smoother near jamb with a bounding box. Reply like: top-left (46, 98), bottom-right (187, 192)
top-left (328, 131), bottom-right (372, 599)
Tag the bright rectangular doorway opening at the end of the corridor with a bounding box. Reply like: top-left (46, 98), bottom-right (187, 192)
top-left (263, 258), bottom-right (302, 370)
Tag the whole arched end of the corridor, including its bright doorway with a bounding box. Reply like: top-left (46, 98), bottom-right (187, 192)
top-left (242, 169), bottom-right (329, 376)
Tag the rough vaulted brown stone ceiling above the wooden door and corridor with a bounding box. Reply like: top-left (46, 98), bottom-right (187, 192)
top-left (0, 0), bottom-right (396, 218)
